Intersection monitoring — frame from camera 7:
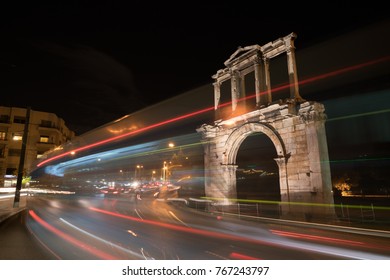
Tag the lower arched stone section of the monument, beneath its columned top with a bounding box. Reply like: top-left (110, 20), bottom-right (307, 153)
top-left (198, 102), bottom-right (334, 217)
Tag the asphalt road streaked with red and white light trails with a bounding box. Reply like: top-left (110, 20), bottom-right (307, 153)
top-left (0, 192), bottom-right (390, 260)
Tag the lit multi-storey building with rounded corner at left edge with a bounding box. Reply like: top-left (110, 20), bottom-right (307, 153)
top-left (0, 106), bottom-right (75, 187)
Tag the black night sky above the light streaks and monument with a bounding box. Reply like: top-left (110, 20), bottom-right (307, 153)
top-left (0, 1), bottom-right (388, 134)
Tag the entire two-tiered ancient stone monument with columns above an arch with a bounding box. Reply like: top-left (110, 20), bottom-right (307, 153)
top-left (197, 33), bottom-right (334, 220)
